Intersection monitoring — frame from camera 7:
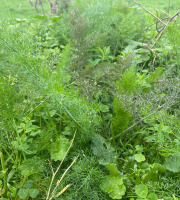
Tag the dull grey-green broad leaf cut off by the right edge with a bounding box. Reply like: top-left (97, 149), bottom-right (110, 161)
top-left (165, 153), bottom-right (180, 172)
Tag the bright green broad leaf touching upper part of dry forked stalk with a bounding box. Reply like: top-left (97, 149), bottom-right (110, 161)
top-left (50, 138), bottom-right (70, 161)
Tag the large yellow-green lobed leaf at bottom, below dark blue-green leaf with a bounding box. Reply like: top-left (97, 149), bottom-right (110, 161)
top-left (100, 174), bottom-right (126, 199)
